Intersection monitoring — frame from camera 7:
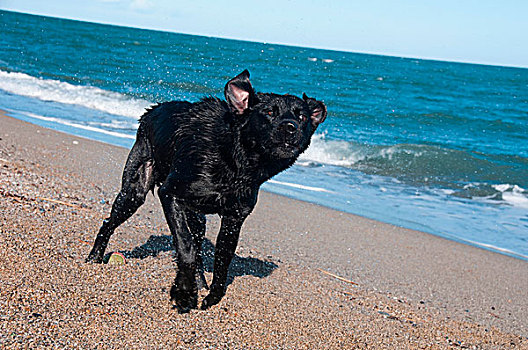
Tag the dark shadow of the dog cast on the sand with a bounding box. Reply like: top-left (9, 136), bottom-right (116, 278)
top-left (118, 235), bottom-right (278, 285)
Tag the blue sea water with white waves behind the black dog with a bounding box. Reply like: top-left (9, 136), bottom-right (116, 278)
top-left (0, 11), bottom-right (528, 260)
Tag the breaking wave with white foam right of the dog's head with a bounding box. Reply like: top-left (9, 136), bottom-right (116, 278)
top-left (297, 134), bottom-right (528, 208)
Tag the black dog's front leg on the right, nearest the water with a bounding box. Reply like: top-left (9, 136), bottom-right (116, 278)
top-left (202, 216), bottom-right (246, 310)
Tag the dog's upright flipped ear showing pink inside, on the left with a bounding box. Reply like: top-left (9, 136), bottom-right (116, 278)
top-left (224, 69), bottom-right (255, 114)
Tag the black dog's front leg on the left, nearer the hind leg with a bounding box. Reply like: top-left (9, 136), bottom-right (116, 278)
top-left (159, 186), bottom-right (199, 313)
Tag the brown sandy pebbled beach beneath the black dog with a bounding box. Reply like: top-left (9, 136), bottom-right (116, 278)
top-left (0, 113), bottom-right (528, 349)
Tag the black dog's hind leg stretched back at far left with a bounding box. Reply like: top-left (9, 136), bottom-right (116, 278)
top-left (86, 132), bottom-right (154, 263)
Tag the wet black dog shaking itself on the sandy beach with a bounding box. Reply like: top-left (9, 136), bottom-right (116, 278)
top-left (86, 70), bottom-right (326, 312)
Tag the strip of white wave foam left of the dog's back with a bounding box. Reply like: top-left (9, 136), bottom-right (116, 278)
top-left (0, 70), bottom-right (152, 119)
